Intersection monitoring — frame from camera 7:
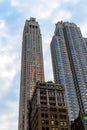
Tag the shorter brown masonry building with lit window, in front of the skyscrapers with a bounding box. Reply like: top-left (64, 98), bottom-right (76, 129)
top-left (30, 82), bottom-right (70, 130)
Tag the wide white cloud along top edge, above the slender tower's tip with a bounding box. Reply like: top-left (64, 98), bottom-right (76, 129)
top-left (10, 0), bottom-right (60, 19)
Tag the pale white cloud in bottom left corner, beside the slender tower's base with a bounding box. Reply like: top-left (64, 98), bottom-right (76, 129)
top-left (0, 101), bottom-right (18, 130)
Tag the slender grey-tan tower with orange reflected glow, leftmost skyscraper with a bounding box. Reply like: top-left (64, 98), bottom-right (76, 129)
top-left (19, 18), bottom-right (44, 130)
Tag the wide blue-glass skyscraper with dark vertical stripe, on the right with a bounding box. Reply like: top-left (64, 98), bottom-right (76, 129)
top-left (51, 22), bottom-right (87, 121)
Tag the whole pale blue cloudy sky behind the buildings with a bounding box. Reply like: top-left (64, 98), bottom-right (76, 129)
top-left (0, 0), bottom-right (87, 130)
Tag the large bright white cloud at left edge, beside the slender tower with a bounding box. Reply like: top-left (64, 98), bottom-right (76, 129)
top-left (0, 20), bottom-right (20, 99)
